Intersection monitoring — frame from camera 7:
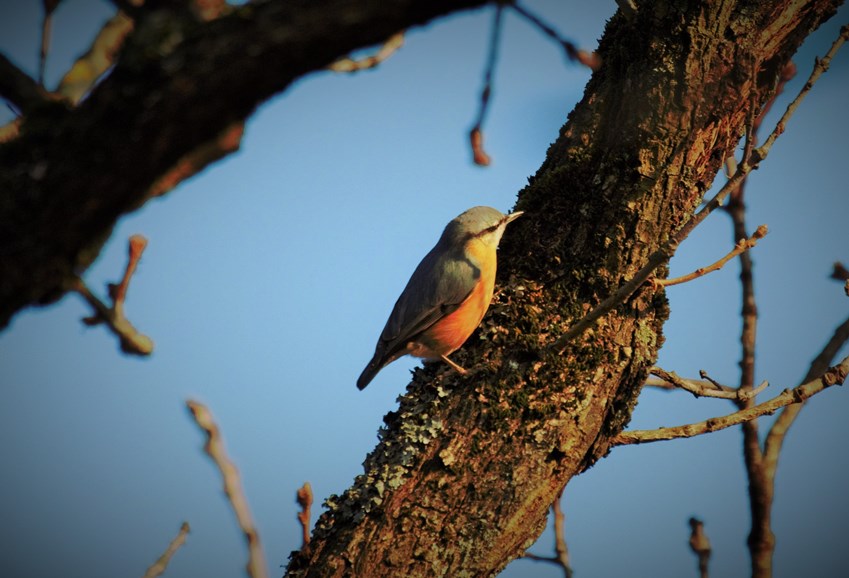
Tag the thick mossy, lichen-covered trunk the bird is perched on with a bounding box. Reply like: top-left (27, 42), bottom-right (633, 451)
top-left (287, 0), bottom-right (839, 577)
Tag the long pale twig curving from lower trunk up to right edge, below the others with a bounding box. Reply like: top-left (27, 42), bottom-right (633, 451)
top-left (611, 357), bottom-right (849, 446)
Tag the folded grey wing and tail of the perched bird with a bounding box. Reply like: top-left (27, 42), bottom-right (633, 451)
top-left (357, 244), bottom-right (480, 389)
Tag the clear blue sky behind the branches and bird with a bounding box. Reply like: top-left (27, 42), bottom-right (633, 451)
top-left (0, 0), bottom-right (849, 578)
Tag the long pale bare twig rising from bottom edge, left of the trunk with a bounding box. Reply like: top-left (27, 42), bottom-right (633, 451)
top-left (186, 400), bottom-right (268, 578)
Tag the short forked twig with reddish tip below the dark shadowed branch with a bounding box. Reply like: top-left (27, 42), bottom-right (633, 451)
top-left (69, 235), bottom-right (153, 355)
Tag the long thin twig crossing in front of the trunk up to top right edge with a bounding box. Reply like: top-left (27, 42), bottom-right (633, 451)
top-left (551, 26), bottom-right (849, 353)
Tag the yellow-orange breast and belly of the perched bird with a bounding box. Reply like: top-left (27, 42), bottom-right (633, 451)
top-left (412, 241), bottom-right (496, 357)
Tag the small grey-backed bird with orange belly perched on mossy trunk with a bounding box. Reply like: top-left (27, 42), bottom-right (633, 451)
top-left (357, 206), bottom-right (523, 390)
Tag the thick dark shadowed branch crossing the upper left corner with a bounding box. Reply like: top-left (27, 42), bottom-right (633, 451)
top-left (0, 0), bottom-right (483, 329)
